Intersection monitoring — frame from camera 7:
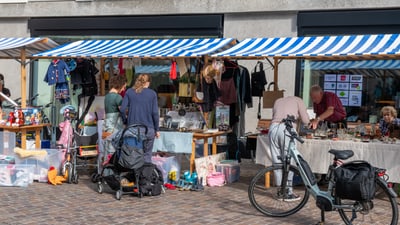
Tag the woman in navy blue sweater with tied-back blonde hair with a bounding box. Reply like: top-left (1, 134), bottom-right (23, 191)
top-left (120, 74), bottom-right (160, 163)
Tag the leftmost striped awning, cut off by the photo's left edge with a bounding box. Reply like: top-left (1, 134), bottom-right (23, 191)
top-left (0, 37), bottom-right (58, 59)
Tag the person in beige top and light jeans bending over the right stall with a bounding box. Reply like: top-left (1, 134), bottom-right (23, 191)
top-left (268, 96), bottom-right (310, 201)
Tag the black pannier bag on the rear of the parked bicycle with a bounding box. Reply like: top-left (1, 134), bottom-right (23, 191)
top-left (335, 161), bottom-right (376, 201)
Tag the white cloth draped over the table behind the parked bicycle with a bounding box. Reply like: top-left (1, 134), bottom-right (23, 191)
top-left (256, 135), bottom-right (400, 183)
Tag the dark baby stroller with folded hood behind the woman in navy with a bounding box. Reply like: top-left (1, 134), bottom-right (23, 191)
top-left (97, 124), bottom-right (163, 200)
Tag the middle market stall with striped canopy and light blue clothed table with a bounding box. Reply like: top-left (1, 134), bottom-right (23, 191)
top-left (35, 38), bottom-right (241, 177)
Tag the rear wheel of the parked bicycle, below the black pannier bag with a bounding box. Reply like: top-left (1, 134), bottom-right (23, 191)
top-left (336, 179), bottom-right (398, 225)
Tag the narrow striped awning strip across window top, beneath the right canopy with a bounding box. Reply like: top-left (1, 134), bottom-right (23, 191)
top-left (302, 60), bottom-right (400, 70)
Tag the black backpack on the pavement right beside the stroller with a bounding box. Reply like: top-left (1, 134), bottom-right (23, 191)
top-left (139, 163), bottom-right (164, 196)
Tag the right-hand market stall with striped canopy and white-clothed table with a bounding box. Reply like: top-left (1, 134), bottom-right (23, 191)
top-left (211, 34), bottom-right (400, 179)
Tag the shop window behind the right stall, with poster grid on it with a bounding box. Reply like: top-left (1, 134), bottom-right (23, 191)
top-left (300, 60), bottom-right (400, 123)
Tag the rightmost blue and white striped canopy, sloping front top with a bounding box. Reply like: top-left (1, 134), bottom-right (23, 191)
top-left (212, 34), bottom-right (400, 58)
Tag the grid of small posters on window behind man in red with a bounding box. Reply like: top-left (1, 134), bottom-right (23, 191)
top-left (324, 74), bottom-right (363, 106)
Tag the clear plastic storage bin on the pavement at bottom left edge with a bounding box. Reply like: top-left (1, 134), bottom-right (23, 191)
top-left (0, 164), bottom-right (34, 187)
